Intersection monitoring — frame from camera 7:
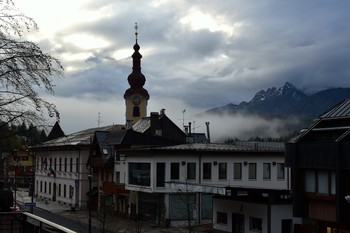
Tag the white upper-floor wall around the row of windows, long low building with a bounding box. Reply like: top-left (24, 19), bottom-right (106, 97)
top-left (124, 152), bottom-right (290, 192)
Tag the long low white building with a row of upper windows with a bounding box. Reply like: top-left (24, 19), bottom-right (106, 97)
top-left (121, 142), bottom-right (298, 233)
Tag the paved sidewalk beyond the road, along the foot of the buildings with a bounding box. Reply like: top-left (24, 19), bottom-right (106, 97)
top-left (16, 189), bottom-right (188, 233)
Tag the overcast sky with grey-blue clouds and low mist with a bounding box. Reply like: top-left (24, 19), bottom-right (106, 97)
top-left (14, 0), bottom-right (350, 140)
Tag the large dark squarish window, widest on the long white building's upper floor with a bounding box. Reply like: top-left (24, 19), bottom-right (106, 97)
top-left (129, 163), bottom-right (151, 186)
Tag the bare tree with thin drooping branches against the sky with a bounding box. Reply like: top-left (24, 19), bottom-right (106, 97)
top-left (0, 0), bottom-right (63, 129)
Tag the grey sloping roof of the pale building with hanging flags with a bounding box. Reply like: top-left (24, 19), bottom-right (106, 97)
top-left (33, 125), bottom-right (125, 148)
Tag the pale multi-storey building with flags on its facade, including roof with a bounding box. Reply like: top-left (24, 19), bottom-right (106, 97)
top-left (32, 126), bottom-right (111, 210)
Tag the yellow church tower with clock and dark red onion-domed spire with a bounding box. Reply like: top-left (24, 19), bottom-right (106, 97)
top-left (124, 23), bottom-right (149, 126)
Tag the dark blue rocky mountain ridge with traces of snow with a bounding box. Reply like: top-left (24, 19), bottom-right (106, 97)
top-left (206, 82), bottom-right (350, 119)
